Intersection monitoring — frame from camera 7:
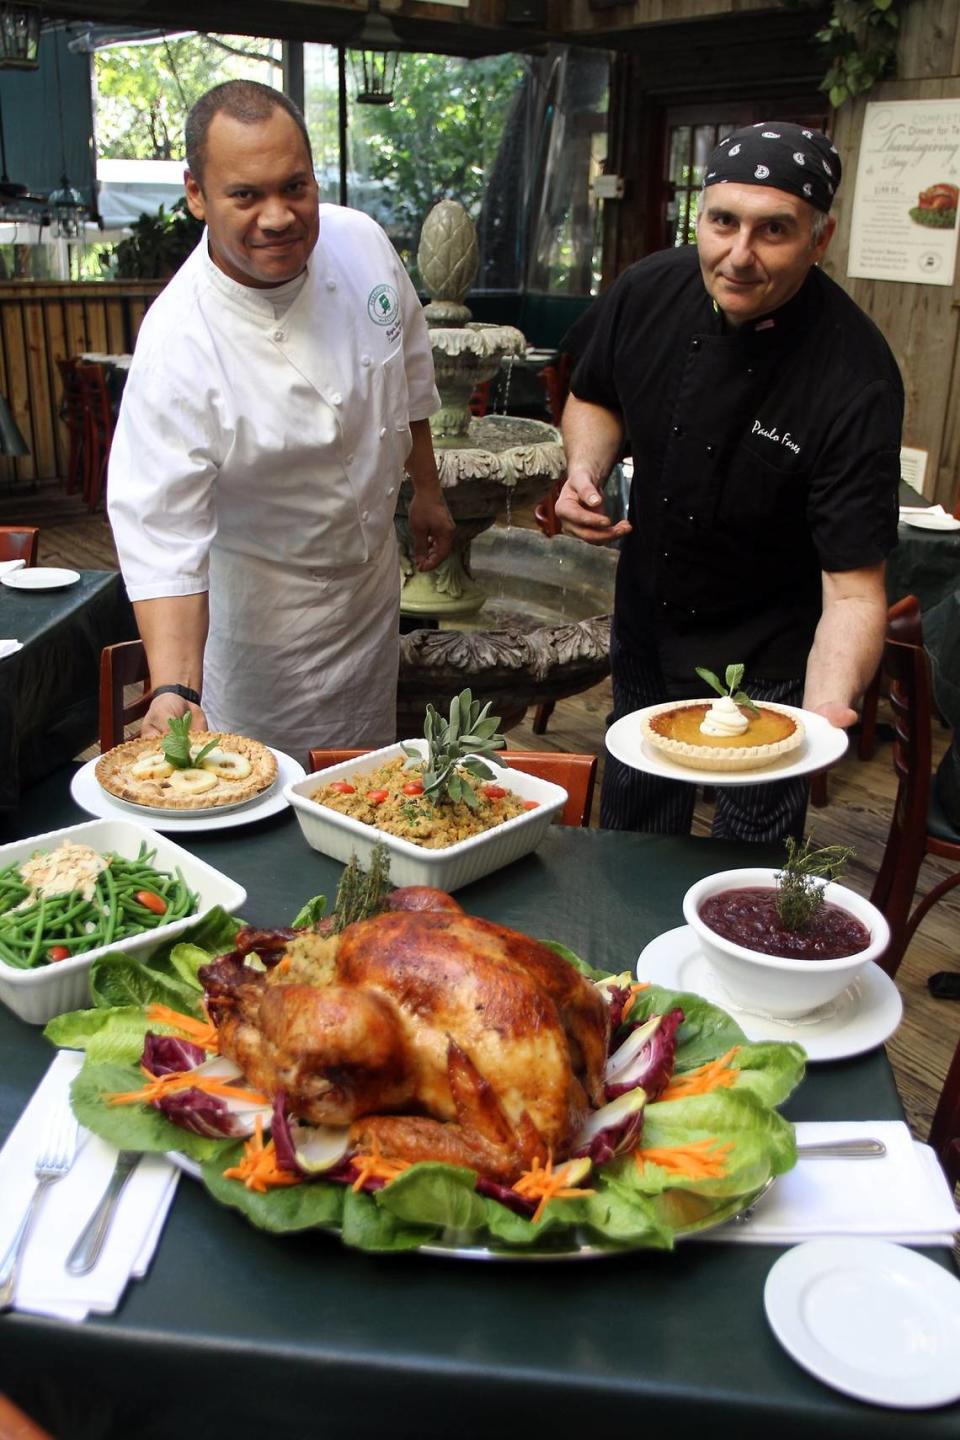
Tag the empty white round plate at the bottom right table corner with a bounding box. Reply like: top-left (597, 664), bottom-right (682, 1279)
top-left (763, 1237), bottom-right (960, 1410)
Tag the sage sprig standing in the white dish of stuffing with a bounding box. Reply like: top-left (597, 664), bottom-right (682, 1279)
top-left (403, 690), bottom-right (507, 809)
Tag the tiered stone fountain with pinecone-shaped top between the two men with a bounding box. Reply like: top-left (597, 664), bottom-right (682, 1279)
top-left (396, 200), bottom-right (616, 736)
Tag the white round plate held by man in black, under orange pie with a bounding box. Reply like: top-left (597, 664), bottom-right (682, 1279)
top-left (606, 701), bottom-right (848, 785)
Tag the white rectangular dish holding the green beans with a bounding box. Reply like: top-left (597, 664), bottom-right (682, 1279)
top-left (0, 819), bottom-right (246, 1025)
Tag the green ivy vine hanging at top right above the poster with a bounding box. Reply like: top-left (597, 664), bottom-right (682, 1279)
top-left (784, 0), bottom-right (910, 109)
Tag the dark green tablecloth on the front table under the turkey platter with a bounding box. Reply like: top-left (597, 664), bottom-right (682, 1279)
top-left (0, 776), bottom-right (960, 1440)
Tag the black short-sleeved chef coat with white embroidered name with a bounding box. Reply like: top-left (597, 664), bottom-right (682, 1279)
top-left (571, 246), bottom-right (904, 696)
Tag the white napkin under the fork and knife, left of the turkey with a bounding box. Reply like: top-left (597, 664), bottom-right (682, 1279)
top-left (0, 1050), bottom-right (180, 1320)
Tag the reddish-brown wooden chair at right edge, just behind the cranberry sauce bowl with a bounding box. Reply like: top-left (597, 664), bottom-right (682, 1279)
top-left (871, 596), bottom-right (960, 975)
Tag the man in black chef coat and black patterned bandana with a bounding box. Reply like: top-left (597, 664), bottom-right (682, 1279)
top-left (557, 121), bottom-right (904, 841)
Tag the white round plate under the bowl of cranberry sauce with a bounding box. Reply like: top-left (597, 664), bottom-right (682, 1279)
top-left (636, 924), bottom-right (904, 1063)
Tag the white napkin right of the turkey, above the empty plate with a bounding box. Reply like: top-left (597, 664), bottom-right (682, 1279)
top-left (697, 1120), bottom-right (960, 1246)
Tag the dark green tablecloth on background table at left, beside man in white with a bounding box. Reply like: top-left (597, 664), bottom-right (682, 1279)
top-left (0, 570), bottom-right (137, 811)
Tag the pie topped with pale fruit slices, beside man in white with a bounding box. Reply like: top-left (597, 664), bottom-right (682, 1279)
top-left (96, 730), bottom-right (276, 811)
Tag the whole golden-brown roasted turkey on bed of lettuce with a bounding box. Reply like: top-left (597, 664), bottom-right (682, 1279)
top-left (200, 887), bottom-right (609, 1184)
